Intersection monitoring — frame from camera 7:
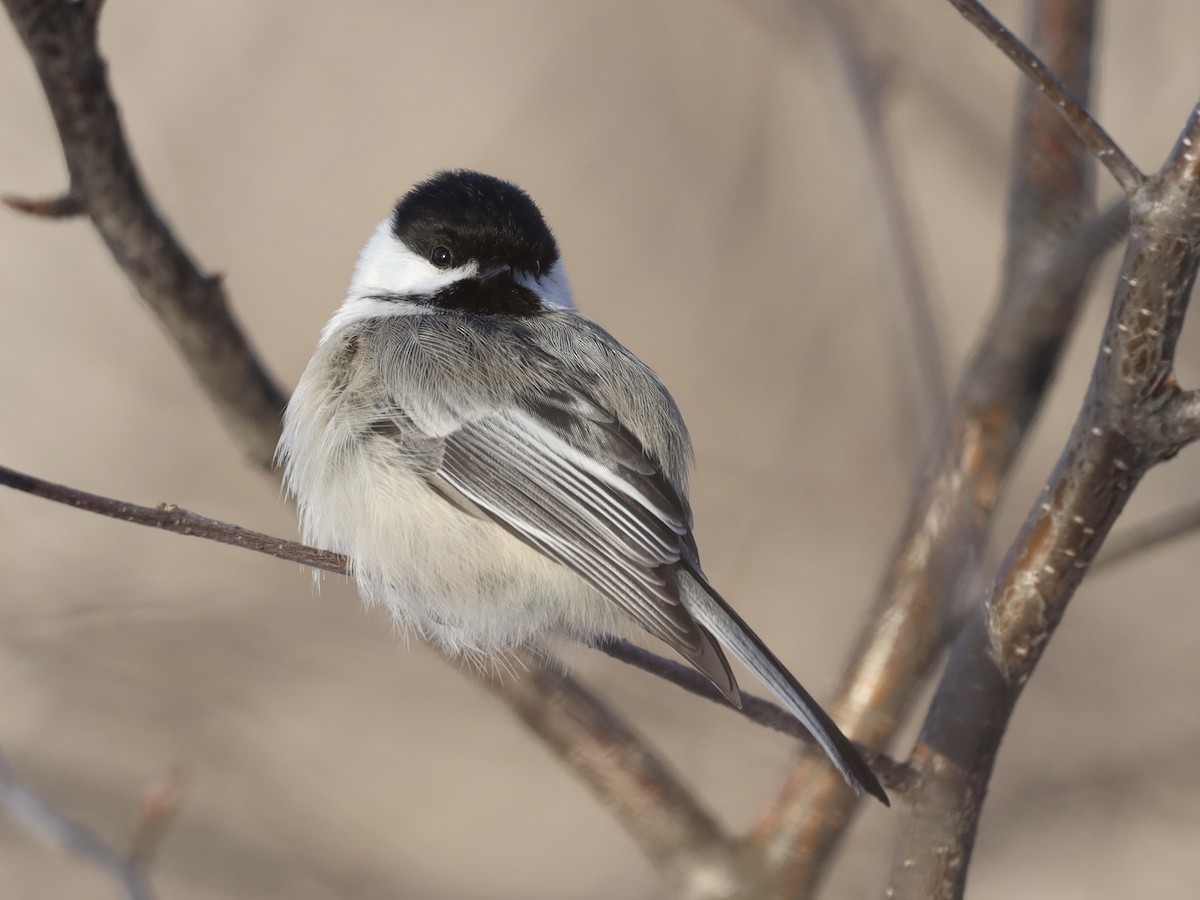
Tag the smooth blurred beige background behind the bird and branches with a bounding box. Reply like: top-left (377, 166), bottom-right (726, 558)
top-left (0, 0), bottom-right (1200, 900)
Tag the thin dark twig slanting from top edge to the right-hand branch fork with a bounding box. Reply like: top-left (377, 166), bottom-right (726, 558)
top-left (950, 0), bottom-right (1146, 197)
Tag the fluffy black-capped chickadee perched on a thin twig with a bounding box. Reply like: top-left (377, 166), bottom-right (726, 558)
top-left (277, 170), bottom-right (887, 803)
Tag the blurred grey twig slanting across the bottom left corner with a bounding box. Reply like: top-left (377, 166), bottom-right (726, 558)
top-left (0, 756), bottom-right (155, 900)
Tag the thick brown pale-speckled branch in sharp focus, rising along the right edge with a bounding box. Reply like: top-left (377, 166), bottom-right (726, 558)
top-left (889, 98), bottom-right (1200, 900)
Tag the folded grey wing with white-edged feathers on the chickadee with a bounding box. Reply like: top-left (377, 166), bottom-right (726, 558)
top-left (410, 389), bottom-right (740, 706)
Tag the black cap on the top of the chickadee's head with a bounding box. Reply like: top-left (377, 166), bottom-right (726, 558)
top-left (391, 169), bottom-right (558, 275)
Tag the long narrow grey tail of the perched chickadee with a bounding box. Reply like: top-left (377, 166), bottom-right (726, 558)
top-left (679, 563), bottom-right (890, 805)
